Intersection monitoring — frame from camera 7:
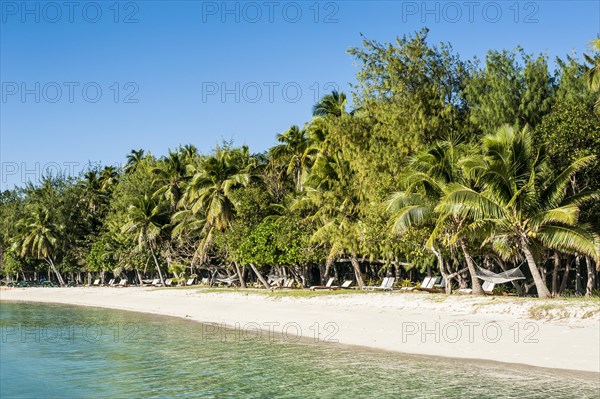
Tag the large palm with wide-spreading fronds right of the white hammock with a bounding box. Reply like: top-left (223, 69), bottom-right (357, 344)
top-left (436, 126), bottom-right (600, 298)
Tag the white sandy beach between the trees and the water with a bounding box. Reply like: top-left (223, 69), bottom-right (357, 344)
top-left (0, 287), bottom-right (600, 373)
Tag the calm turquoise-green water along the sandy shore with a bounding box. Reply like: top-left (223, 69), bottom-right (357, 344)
top-left (0, 302), bottom-right (600, 399)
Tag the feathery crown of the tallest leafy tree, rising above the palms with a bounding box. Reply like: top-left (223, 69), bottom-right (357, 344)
top-left (349, 29), bottom-right (468, 147)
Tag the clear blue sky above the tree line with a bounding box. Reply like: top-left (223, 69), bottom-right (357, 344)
top-left (0, 0), bottom-right (600, 189)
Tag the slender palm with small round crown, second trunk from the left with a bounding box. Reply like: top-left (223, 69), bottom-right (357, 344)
top-left (121, 194), bottom-right (167, 285)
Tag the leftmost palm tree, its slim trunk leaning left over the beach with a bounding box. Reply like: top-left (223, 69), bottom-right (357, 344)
top-left (15, 206), bottom-right (65, 287)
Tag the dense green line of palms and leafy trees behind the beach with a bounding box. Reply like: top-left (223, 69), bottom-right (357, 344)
top-left (0, 30), bottom-right (600, 297)
